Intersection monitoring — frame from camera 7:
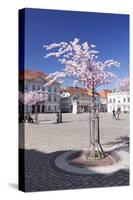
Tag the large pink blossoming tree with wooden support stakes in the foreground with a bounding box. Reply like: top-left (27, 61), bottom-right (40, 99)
top-left (44, 38), bottom-right (120, 157)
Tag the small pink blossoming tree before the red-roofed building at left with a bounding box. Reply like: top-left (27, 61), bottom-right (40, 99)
top-left (19, 90), bottom-right (47, 123)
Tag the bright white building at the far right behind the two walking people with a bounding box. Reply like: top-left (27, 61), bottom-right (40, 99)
top-left (107, 92), bottom-right (130, 112)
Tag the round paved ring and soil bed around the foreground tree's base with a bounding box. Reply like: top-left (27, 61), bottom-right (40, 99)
top-left (54, 149), bottom-right (129, 175)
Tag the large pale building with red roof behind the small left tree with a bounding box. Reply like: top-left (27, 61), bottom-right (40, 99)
top-left (19, 71), bottom-right (60, 113)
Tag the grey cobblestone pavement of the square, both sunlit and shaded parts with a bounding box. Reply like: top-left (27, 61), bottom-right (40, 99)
top-left (20, 113), bottom-right (129, 192)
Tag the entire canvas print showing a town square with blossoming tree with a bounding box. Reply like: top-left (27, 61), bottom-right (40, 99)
top-left (19, 9), bottom-right (130, 192)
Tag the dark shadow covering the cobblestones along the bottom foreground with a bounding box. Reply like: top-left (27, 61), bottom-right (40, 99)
top-left (19, 149), bottom-right (129, 192)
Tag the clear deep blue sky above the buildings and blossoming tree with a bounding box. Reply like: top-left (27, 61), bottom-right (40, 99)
top-left (25, 9), bottom-right (129, 88)
